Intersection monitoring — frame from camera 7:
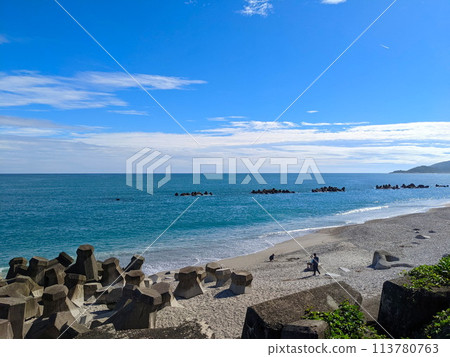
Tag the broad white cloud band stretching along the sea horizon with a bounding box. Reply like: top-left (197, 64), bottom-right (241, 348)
top-left (0, 116), bottom-right (450, 172)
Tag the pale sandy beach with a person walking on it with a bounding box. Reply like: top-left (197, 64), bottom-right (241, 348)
top-left (157, 206), bottom-right (450, 338)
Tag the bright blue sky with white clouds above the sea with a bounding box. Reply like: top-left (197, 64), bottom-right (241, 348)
top-left (0, 0), bottom-right (450, 173)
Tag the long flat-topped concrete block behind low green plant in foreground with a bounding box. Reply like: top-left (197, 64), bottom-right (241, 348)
top-left (242, 282), bottom-right (362, 338)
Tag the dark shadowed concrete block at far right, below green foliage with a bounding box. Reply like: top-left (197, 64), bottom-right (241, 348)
top-left (378, 277), bottom-right (450, 338)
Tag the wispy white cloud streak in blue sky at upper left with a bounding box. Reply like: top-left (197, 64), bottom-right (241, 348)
top-left (0, 70), bottom-right (206, 109)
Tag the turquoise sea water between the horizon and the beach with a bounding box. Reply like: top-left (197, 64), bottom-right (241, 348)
top-left (0, 174), bottom-right (450, 273)
